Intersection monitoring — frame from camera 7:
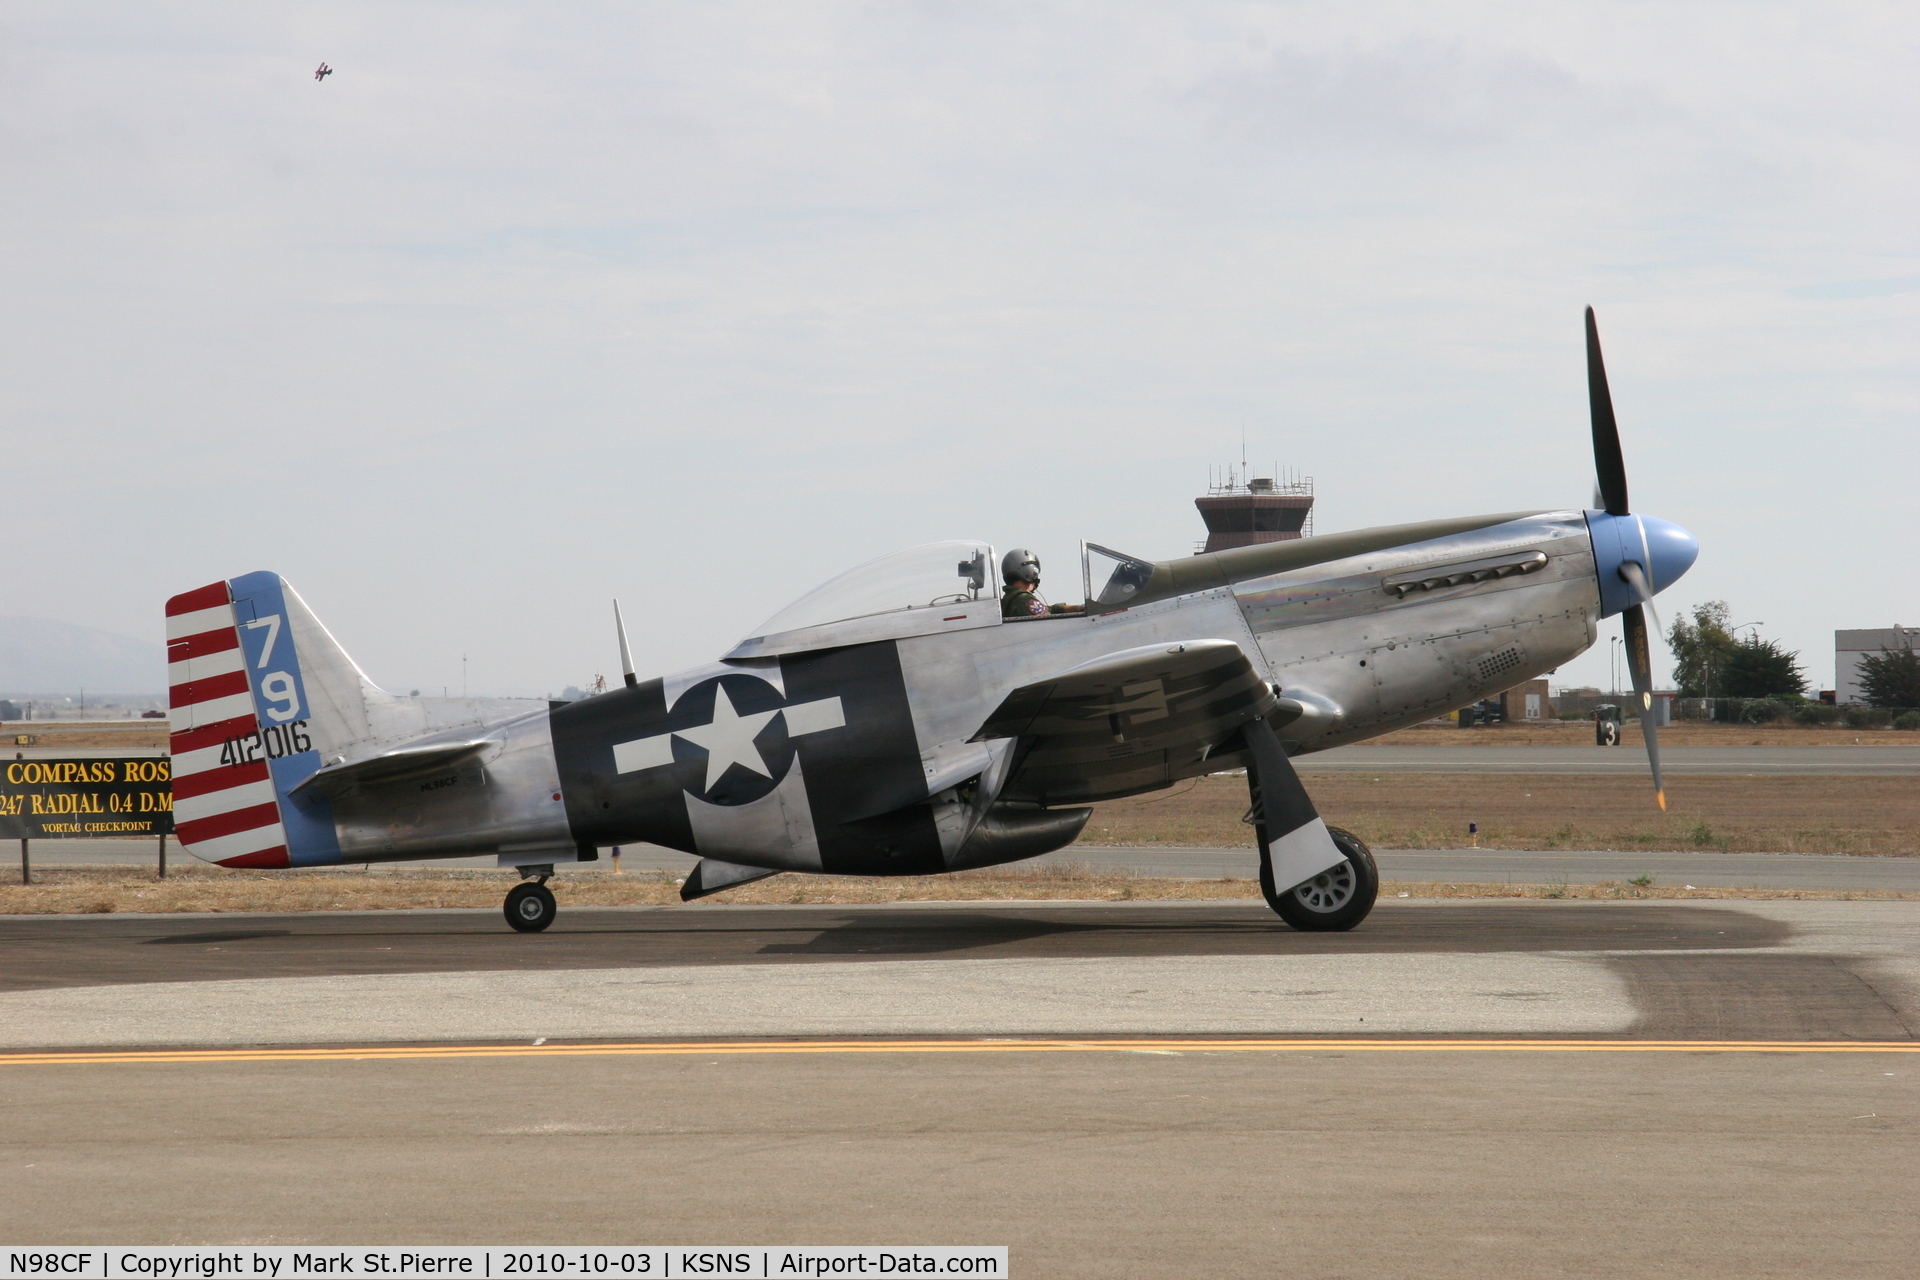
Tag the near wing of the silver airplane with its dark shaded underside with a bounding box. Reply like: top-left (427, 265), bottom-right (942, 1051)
top-left (972, 639), bottom-right (1277, 804)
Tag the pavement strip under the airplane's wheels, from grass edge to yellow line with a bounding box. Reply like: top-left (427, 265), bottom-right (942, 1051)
top-left (0, 900), bottom-right (1920, 1050)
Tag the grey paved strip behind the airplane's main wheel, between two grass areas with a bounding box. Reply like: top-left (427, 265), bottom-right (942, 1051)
top-left (30, 841), bottom-right (1920, 892)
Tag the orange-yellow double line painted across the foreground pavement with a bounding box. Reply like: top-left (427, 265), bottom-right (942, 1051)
top-left (0, 1036), bottom-right (1920, 1067)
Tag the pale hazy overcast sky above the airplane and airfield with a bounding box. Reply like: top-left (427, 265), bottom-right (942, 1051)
top-left (0, 0), bottom-right (1920, 693)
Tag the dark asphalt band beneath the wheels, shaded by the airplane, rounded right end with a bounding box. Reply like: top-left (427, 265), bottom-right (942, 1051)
top-left (0, 902), bottom-right (1791, 990)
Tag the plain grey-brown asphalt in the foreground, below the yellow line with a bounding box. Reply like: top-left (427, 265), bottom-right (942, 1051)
top-left (0, 1052), bottom-right (1920, 1280)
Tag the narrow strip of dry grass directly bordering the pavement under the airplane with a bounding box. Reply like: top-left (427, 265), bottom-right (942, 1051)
top-left (0, 864), bottom-right (1920, 915)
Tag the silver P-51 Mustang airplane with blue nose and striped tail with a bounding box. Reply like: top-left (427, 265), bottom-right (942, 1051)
top-left (167, 311), bottom-right (1697, 931)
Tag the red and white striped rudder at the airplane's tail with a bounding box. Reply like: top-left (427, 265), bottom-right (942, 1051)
top-left (167, 581), bottom-right (288, 867)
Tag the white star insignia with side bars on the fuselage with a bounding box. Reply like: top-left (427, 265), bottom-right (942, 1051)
top-left (612, 674), bottom-right (847, 804)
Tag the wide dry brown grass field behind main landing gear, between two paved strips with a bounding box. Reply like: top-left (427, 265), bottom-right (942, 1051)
top-left (1081, 773), bottom-right (1920, 856)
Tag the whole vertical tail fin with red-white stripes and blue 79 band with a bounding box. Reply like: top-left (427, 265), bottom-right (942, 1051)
top-left (167, 572), bottom-right (374, 867)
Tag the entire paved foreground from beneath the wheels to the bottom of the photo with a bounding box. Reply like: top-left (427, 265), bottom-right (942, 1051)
top-left (0, 900), bottom-right (1920, 1276)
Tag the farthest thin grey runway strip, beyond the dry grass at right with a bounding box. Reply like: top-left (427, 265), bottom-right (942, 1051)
top-left (1294, 743), bottom-right (1920, 777)
